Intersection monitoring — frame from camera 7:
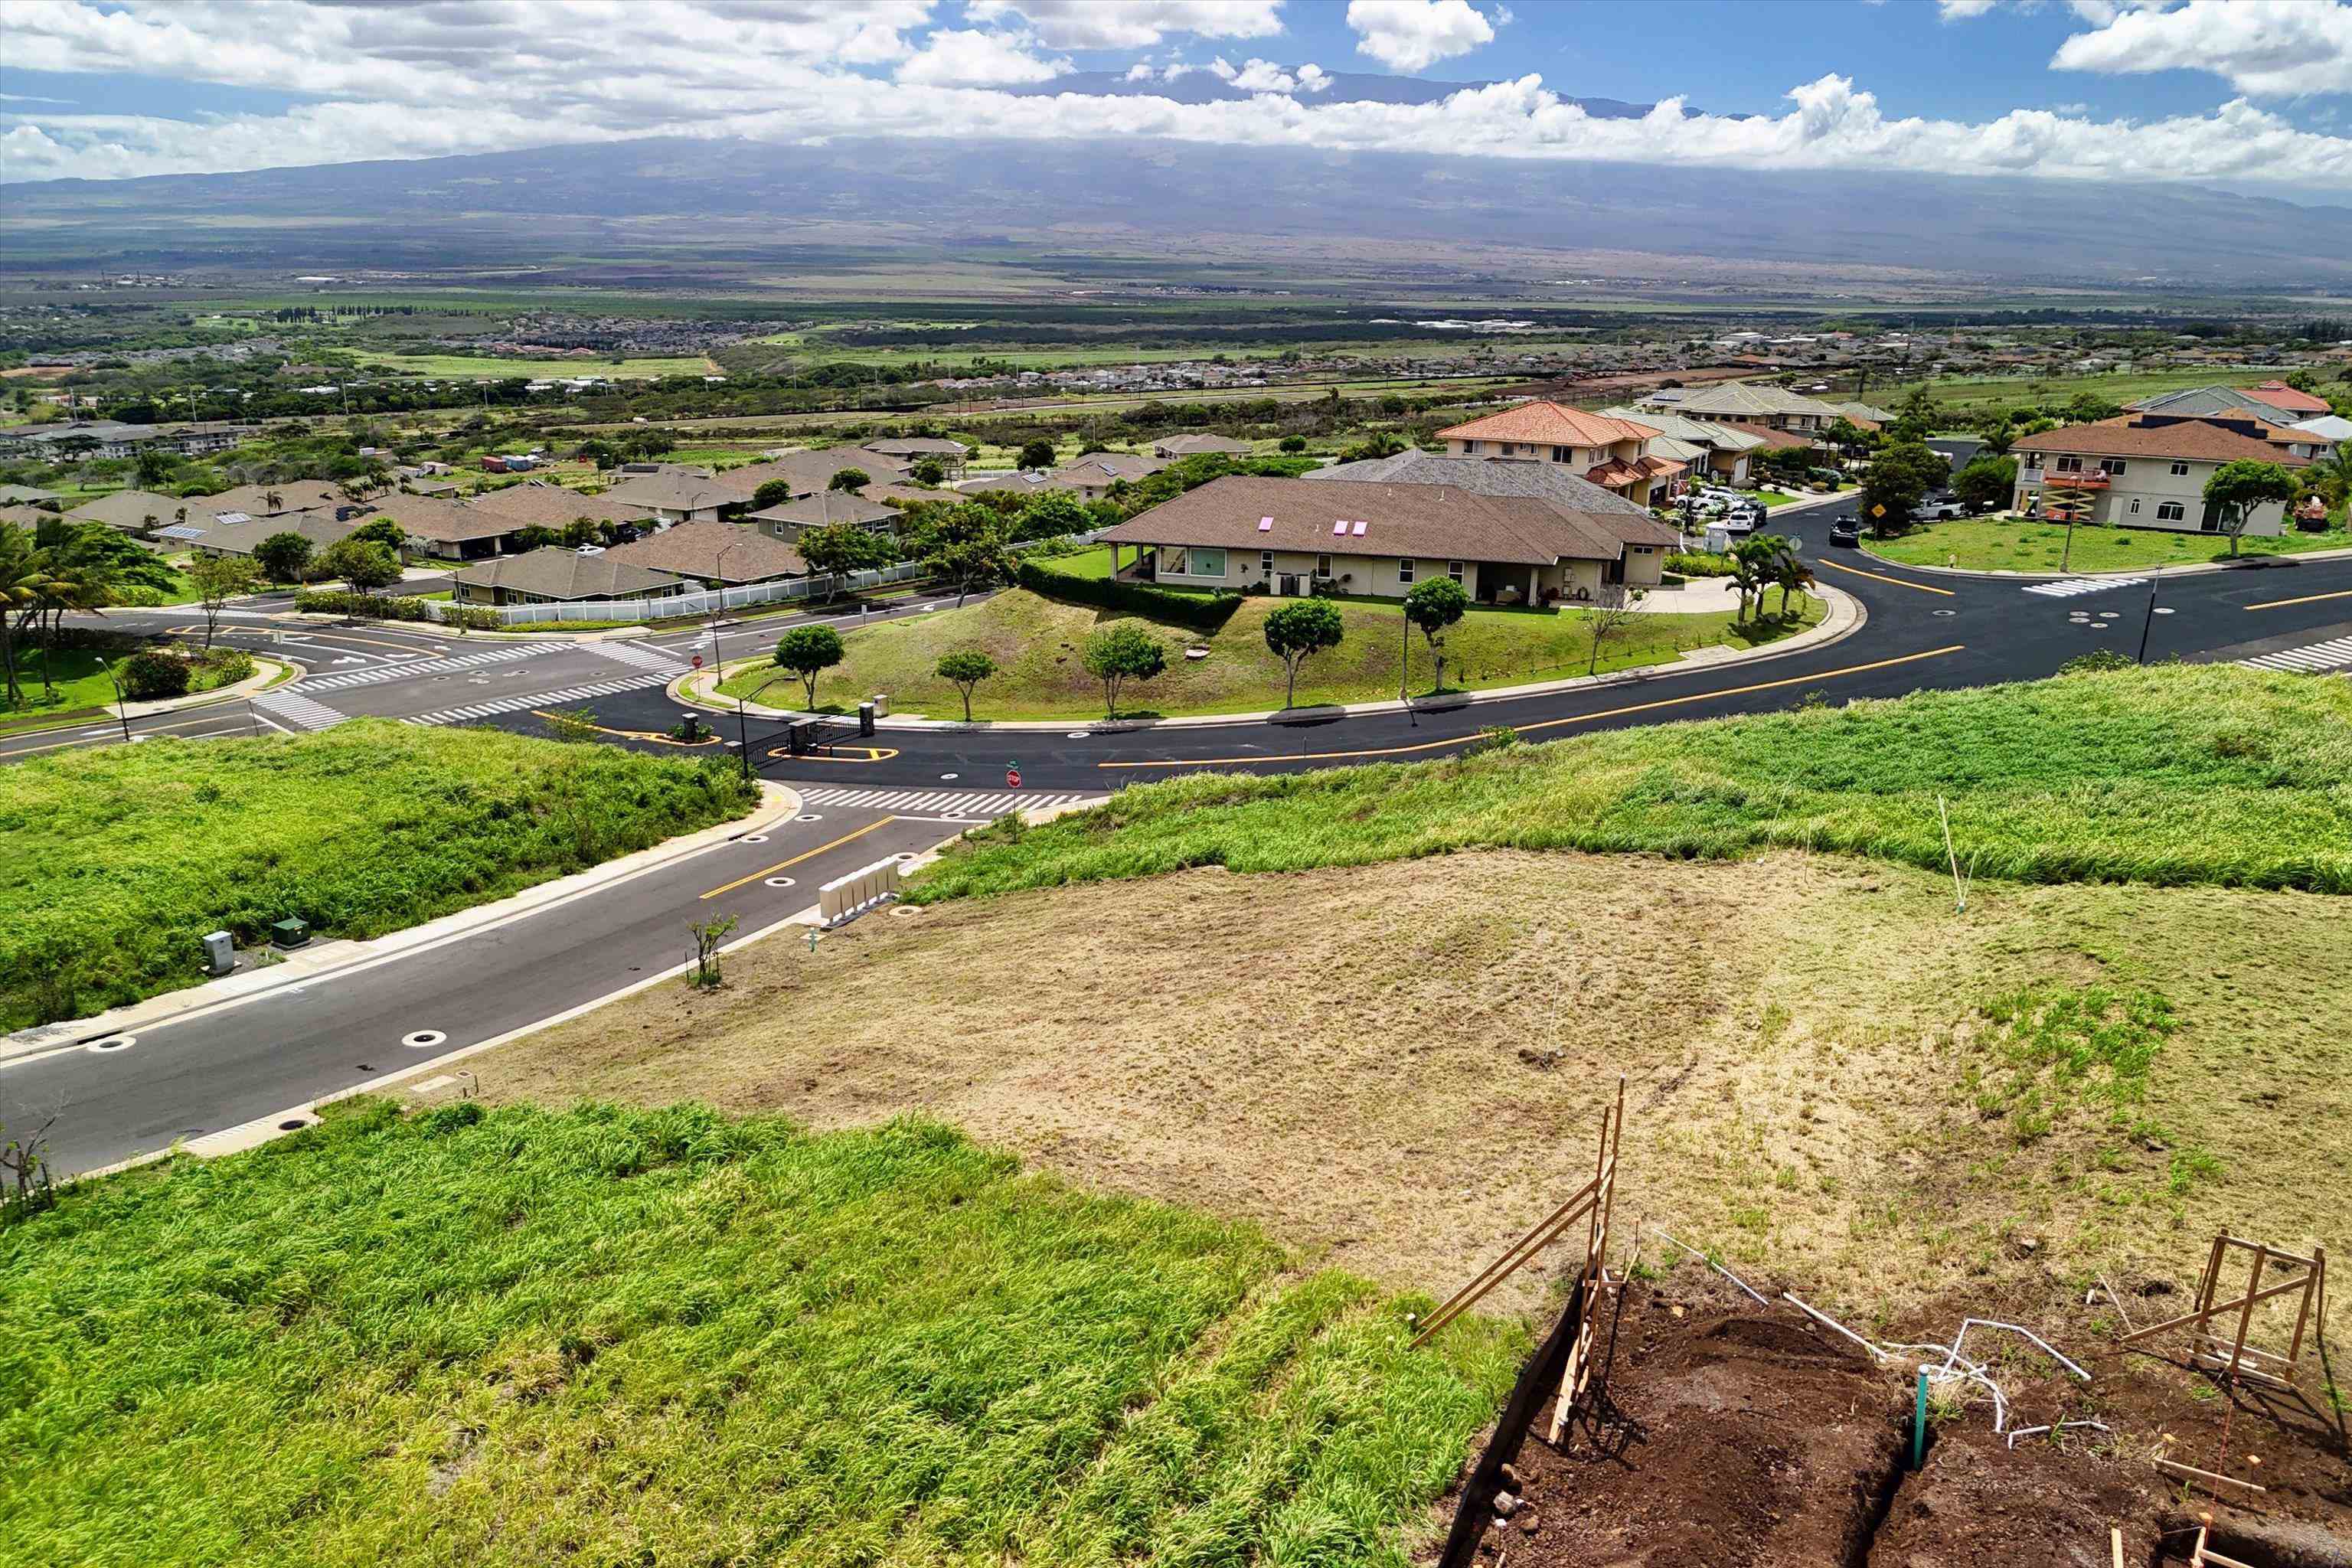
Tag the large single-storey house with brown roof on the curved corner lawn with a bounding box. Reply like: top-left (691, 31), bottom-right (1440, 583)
top-left (1101, 475), bottom-right (1674, 604)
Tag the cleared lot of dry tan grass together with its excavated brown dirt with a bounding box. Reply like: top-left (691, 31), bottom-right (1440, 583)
top-left (433, 851), bottom-right (2352, 1568)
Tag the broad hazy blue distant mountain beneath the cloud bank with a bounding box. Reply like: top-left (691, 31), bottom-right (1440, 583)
top-left (0, 135), bottom-right (2352, 292)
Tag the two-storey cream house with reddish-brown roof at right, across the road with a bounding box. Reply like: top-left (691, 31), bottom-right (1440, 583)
top-left (2008, 413), bottom-right (2308, 534)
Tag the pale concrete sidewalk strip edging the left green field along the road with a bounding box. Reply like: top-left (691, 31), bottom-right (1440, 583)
top-left (0, 780), bottom-right (799, 1063)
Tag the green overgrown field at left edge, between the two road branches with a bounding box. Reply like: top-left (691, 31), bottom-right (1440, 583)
top-left (0, 720), bottom-right (750, 1027)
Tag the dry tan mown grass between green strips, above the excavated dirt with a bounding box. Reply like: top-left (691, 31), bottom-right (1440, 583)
top-left (444, 851), bottom-right (2352, 1344)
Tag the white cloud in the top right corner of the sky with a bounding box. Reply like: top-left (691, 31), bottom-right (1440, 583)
top-left (2051, 0), bottom-right (2352, 99)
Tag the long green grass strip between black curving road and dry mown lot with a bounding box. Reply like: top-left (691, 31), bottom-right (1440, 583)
top-left (910, 665), bottom-right (2352, 900)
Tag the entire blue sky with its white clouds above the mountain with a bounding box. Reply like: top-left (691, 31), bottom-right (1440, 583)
top-left (0, 0), bottom-right (2352, 190)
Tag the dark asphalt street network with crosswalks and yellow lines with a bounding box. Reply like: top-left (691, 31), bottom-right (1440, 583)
top-left (0, 541), bottom-right (2352, 1171)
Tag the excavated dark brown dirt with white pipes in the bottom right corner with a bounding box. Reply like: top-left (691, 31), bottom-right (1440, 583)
top-left (1479, 1265), bottom-right (2352, 1568)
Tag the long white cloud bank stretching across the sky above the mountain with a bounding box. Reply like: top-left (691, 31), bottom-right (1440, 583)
top-left (0, 0), bottom-right (2352, 191)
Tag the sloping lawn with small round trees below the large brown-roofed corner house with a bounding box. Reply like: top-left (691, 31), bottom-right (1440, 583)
top-left (720, 580), bottom-right (1825, 720)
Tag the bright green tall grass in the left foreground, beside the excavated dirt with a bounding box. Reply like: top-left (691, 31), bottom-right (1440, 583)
top-left (0, 1102), bottom-right (1527, 1568)
